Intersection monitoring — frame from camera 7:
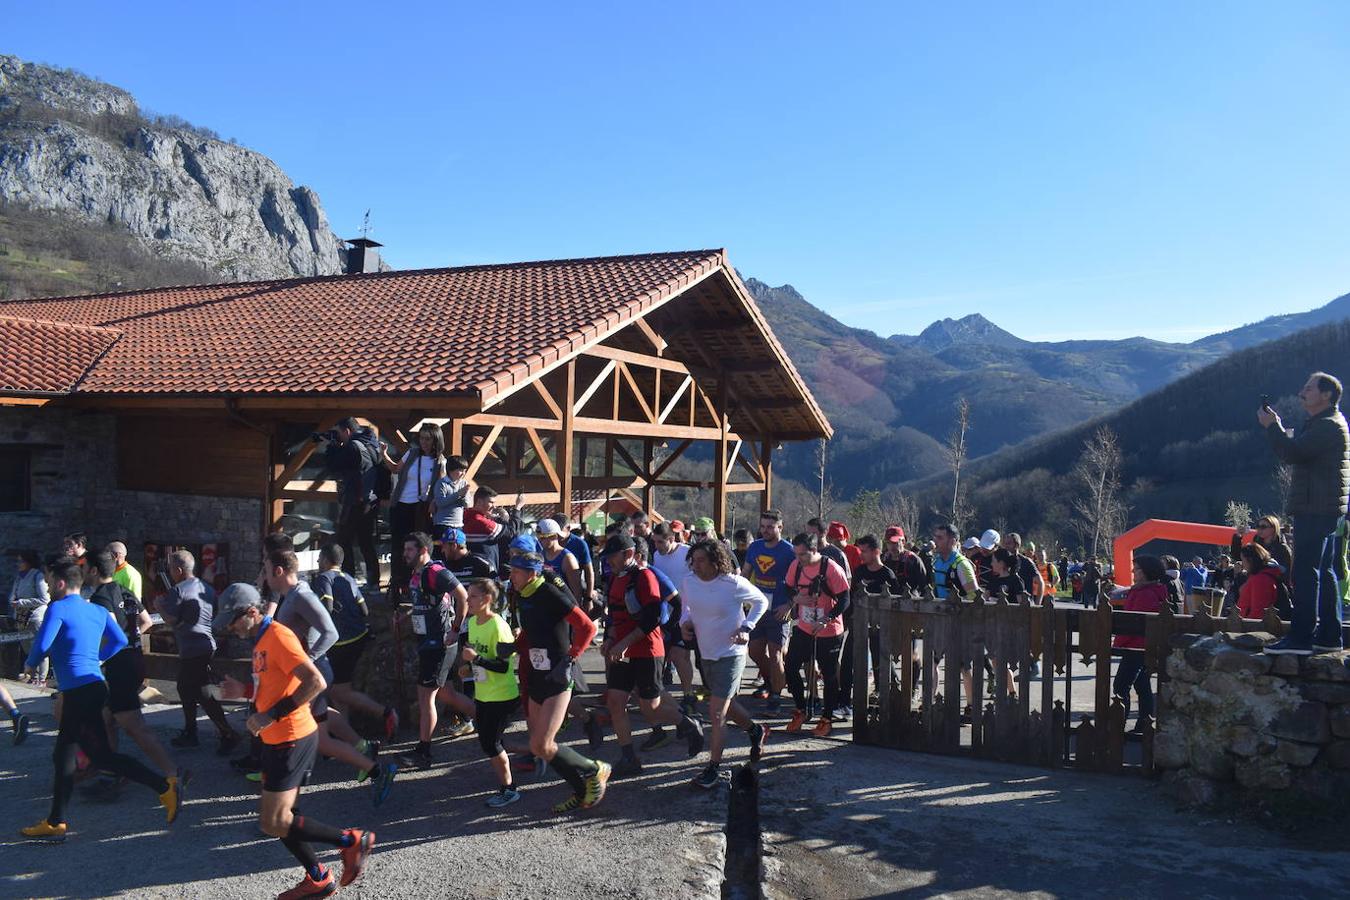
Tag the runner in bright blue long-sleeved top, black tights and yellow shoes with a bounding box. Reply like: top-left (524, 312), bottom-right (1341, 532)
top-left (22, 556), bottom-right (182, 841)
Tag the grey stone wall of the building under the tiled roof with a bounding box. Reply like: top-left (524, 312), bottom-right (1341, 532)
top-left (0, 409), bottom-right (262, 590)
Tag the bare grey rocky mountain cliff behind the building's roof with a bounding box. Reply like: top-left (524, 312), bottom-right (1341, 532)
top-left (0, 55), bottom-right (343, 279)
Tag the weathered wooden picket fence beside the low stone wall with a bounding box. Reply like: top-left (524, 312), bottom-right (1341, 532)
top-left (852, 592), bottom-right (1288, 773)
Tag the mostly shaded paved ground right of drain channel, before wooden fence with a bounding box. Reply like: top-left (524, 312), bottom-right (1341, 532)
top-left (760, 738), bottom-right (1350, 900)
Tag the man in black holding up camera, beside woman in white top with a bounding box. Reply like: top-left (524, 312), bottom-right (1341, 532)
top-left (325, 416), bottom-right (385, 590)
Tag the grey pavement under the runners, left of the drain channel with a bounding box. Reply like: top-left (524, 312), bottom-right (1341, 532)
top-left (0, 683), bottom-right (744, 900)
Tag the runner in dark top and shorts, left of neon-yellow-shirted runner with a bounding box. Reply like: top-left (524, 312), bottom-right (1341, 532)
top-left (404, 532), bottom-right (473, 769)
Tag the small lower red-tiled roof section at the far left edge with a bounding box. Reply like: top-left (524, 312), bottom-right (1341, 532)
top-left (0, 316), bottom-right (117, 394)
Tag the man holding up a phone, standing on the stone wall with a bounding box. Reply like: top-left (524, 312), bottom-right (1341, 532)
top-left (1257, 372), bottom-right (1350, 656)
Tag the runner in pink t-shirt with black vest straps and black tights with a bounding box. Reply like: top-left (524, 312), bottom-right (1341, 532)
top-left (786, 532), bottom-right (849, 738)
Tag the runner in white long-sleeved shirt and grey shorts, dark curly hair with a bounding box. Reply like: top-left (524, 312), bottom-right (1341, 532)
top-left (679, 538), bottom-right (768, 788)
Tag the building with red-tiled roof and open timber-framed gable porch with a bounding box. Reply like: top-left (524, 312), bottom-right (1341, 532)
top-left (0, 251), bottom-right (832, 580)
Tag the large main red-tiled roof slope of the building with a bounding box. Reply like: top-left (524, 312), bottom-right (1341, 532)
top-left (0, 250), bottom-right (729, 398)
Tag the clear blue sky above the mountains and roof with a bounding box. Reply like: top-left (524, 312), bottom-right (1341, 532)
top-left (0, 0), bottom-right (1350, 340)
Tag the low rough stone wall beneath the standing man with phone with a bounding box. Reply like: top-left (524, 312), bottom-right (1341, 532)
top-left (1153, 633), bottom-right (1350, 806)
